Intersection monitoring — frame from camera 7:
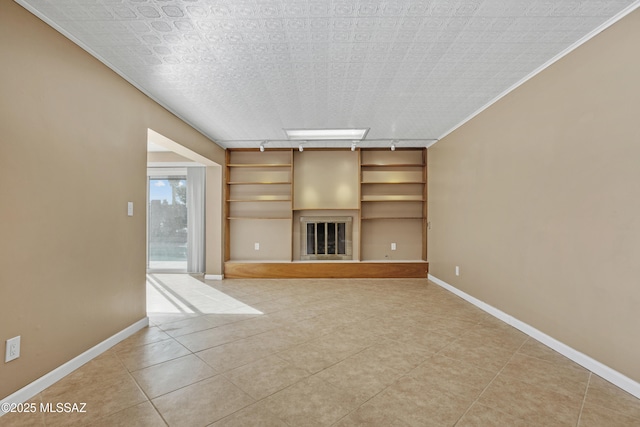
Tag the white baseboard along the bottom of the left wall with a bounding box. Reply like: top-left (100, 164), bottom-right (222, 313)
top-left (0, 317), bottom-right (149, 417)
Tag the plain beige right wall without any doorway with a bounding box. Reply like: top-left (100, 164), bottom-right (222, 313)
top-left (428, 11), bottom-right (640, 381)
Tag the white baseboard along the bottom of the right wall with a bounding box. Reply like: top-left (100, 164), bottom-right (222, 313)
top-left (427, 274), bottom-right (640, 399)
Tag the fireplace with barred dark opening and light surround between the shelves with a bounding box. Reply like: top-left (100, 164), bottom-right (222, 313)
top-left (300, 216), bottom-right (353, 260)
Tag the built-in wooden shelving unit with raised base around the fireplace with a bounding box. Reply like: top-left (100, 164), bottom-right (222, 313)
top-left (225, 148), bottom-right (428, 277)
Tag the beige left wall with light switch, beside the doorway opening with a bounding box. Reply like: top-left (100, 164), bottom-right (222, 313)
top-left (0, 1), bottom-right (224, 398)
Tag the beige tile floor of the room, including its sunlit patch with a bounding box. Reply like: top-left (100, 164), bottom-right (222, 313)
top-left (0, 274), bottom-right (640, 427)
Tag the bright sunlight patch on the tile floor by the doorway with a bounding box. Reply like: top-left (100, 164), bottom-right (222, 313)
top-left (147, 274), bottom-right (262, 314)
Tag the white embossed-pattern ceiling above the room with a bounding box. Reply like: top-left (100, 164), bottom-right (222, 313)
top-left (16, 0), bottom-right (640, 148)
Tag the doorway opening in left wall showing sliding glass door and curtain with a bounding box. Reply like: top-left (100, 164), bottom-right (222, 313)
top-left (146, 129), bottom-right (224, 280)
